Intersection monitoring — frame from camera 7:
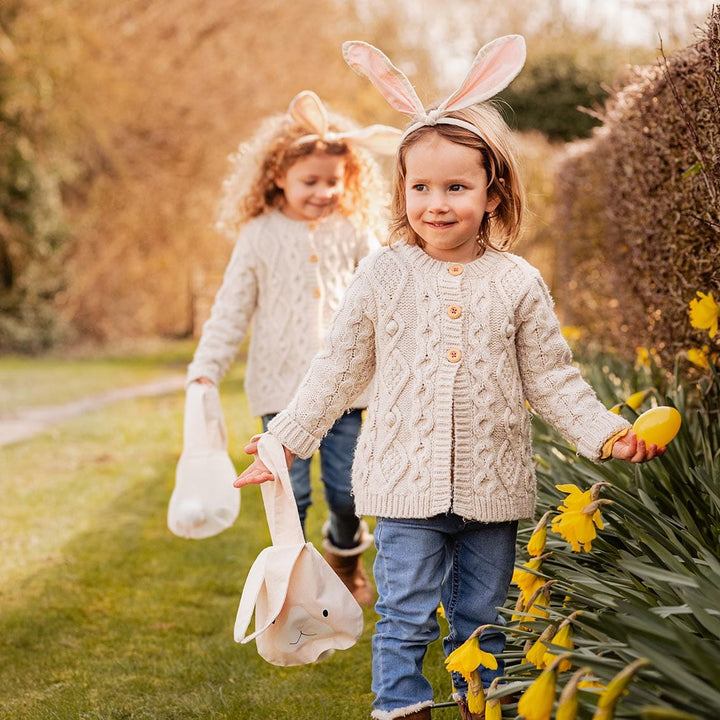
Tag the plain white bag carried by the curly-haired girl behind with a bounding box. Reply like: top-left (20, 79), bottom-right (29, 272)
top-left (167, 383), bottom-right (240, 539)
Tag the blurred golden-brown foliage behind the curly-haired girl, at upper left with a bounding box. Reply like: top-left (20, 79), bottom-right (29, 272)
top-left (22, 0), bottom-right (416, 340)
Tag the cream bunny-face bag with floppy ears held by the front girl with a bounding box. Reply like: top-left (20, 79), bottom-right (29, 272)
top-left (235, 434), bottom-right (363, 666)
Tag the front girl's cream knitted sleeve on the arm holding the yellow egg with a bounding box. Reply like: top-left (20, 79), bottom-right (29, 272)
top-left (516, 274), bottom-right (629, 461)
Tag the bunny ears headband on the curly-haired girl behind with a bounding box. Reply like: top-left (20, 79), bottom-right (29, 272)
top-left (288, 90), bottom-right (402, 155)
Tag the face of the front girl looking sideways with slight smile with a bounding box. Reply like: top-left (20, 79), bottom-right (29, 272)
top-left (405, 133), bottom-right (499, 262)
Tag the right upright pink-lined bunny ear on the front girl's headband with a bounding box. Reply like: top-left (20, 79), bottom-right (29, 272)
top-left (439, 35), bottom-right (526, 110)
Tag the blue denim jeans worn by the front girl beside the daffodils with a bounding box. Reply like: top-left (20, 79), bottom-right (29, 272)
top-left (372, 513), bottom-right (517, 718)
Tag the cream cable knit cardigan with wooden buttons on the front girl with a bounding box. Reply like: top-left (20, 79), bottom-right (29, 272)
top-left (269, 245), bottom-right (628, 522)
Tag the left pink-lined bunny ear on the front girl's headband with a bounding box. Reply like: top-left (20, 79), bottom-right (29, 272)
top-left (343, 40), bottom-right (425, 116)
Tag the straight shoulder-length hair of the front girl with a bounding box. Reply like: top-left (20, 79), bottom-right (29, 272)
top-left (390, 103), bottom-right (525, 251)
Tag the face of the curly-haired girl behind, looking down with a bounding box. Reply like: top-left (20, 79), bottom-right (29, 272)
top-left (275, 151), bottom-right (345, 222)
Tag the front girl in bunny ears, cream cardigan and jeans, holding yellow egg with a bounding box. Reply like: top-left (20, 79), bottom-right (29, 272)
top-left (236, 40), bottom-right (662, 720)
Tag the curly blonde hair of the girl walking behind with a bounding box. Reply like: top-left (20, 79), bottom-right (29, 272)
top-left (215, 108), bottom-right (387, 240)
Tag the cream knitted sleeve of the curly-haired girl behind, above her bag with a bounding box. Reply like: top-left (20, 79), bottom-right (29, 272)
top-left (187, 228), bottom-right (257, 385)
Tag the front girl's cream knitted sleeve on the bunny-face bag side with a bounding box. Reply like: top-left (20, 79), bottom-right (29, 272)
top-left (268, 261), bottom-right (376, 458)
